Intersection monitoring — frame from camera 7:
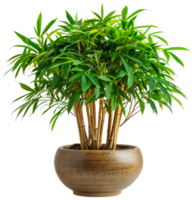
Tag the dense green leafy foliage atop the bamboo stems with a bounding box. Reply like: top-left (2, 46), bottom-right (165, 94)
top-left (2, 2), bottom-right (192, 132)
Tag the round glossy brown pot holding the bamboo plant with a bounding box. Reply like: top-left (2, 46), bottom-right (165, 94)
top-left (52, 143), bottom-right (145, 197)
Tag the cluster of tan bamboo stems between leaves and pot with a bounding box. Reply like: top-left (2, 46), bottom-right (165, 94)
top-left (73, 79), bottom-right (145, 150)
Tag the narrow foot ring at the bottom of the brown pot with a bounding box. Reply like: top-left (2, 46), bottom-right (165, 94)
top-left (71, 191), bottom-right (124, 198)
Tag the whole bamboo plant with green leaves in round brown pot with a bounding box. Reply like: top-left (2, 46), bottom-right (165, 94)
top-left (3, 2), bottom-right (192, 197)
